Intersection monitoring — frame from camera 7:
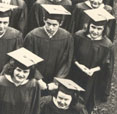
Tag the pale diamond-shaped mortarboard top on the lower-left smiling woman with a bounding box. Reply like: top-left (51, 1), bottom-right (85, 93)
top-left (7, 47), bottom-right (43, 67)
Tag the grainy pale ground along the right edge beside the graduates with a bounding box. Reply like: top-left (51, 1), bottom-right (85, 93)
top-left (94, 0), bottom-right (117, 114)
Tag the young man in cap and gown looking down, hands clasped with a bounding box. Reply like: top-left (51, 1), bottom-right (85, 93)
top-left (24, 4), bottom-right (74, 95)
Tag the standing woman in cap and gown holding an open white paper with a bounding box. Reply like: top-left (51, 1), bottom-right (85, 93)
top-left (69, 9), bottom-right (114, 114)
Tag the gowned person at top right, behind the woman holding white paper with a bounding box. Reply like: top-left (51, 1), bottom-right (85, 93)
top-left (71, 0), bottom-right (116, 42)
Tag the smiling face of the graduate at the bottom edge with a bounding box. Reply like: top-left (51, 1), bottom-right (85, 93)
top-left (56, 91), bottom-right (72, 109)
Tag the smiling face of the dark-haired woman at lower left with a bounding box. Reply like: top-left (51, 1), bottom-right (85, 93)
top-left (14, 67), bottom-right (30, 83)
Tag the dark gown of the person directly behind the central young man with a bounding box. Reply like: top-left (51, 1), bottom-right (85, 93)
top-left (27, 0), bottom-right (72, 32)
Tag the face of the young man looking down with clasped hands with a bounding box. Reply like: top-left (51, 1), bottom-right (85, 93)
top-left (44, 18), bottom-right (60, 34)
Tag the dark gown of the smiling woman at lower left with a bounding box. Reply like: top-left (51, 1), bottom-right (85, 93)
top-left (0, 76), bottom-right (40, 114)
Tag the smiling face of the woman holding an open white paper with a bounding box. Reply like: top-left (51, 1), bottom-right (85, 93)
top-left (89, 24), bottom-right (104, 40)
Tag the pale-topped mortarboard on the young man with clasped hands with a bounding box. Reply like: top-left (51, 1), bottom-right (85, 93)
top-left (41, 4), bottom-right (71, 15)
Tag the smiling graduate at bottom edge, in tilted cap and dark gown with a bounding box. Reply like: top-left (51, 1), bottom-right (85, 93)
top-left (40, 78), bottom-right (88, 114)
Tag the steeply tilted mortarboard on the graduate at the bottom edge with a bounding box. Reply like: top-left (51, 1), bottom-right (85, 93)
top-left (54, 78), bottom-right (85, 92)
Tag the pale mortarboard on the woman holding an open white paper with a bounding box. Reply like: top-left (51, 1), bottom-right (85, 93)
top-left (84, 8), bottom-right (115, 23)
